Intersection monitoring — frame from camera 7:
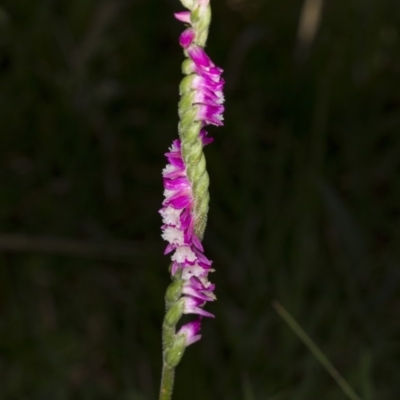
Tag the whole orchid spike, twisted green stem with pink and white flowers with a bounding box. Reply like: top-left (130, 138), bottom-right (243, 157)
top-left (160, 0), bottom-right (224, 399)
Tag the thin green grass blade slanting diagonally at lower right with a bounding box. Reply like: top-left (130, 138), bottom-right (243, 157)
top-left (272, 301), bottom-right (361, 400)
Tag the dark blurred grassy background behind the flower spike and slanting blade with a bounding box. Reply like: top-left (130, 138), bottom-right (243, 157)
top-left (0, 0), bottom-right (400, 400)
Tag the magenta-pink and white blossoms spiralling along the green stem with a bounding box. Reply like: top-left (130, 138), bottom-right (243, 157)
top-left (160, 0), bottom-right (224, 346)
